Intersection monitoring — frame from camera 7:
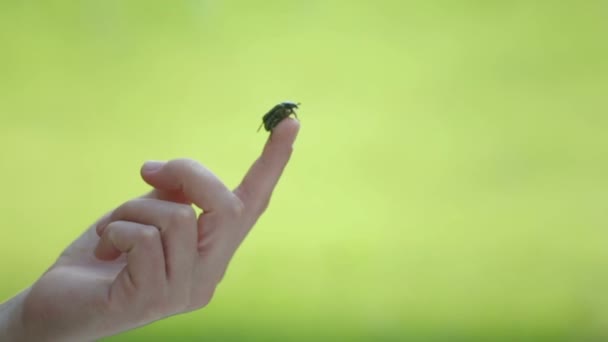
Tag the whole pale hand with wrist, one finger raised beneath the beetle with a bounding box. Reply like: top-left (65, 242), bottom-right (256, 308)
top-left (0, 118), bottom-right (299, 341)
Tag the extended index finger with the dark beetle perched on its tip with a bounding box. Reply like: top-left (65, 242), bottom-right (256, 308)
top-left (234, 118), bottom-right (300, 213)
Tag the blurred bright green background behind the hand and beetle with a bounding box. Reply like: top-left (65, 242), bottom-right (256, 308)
top-left (0, 0), bottom-right (608, 341)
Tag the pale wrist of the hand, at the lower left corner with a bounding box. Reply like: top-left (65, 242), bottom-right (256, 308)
top-left (0, 288), bottom-right (29, 341)
